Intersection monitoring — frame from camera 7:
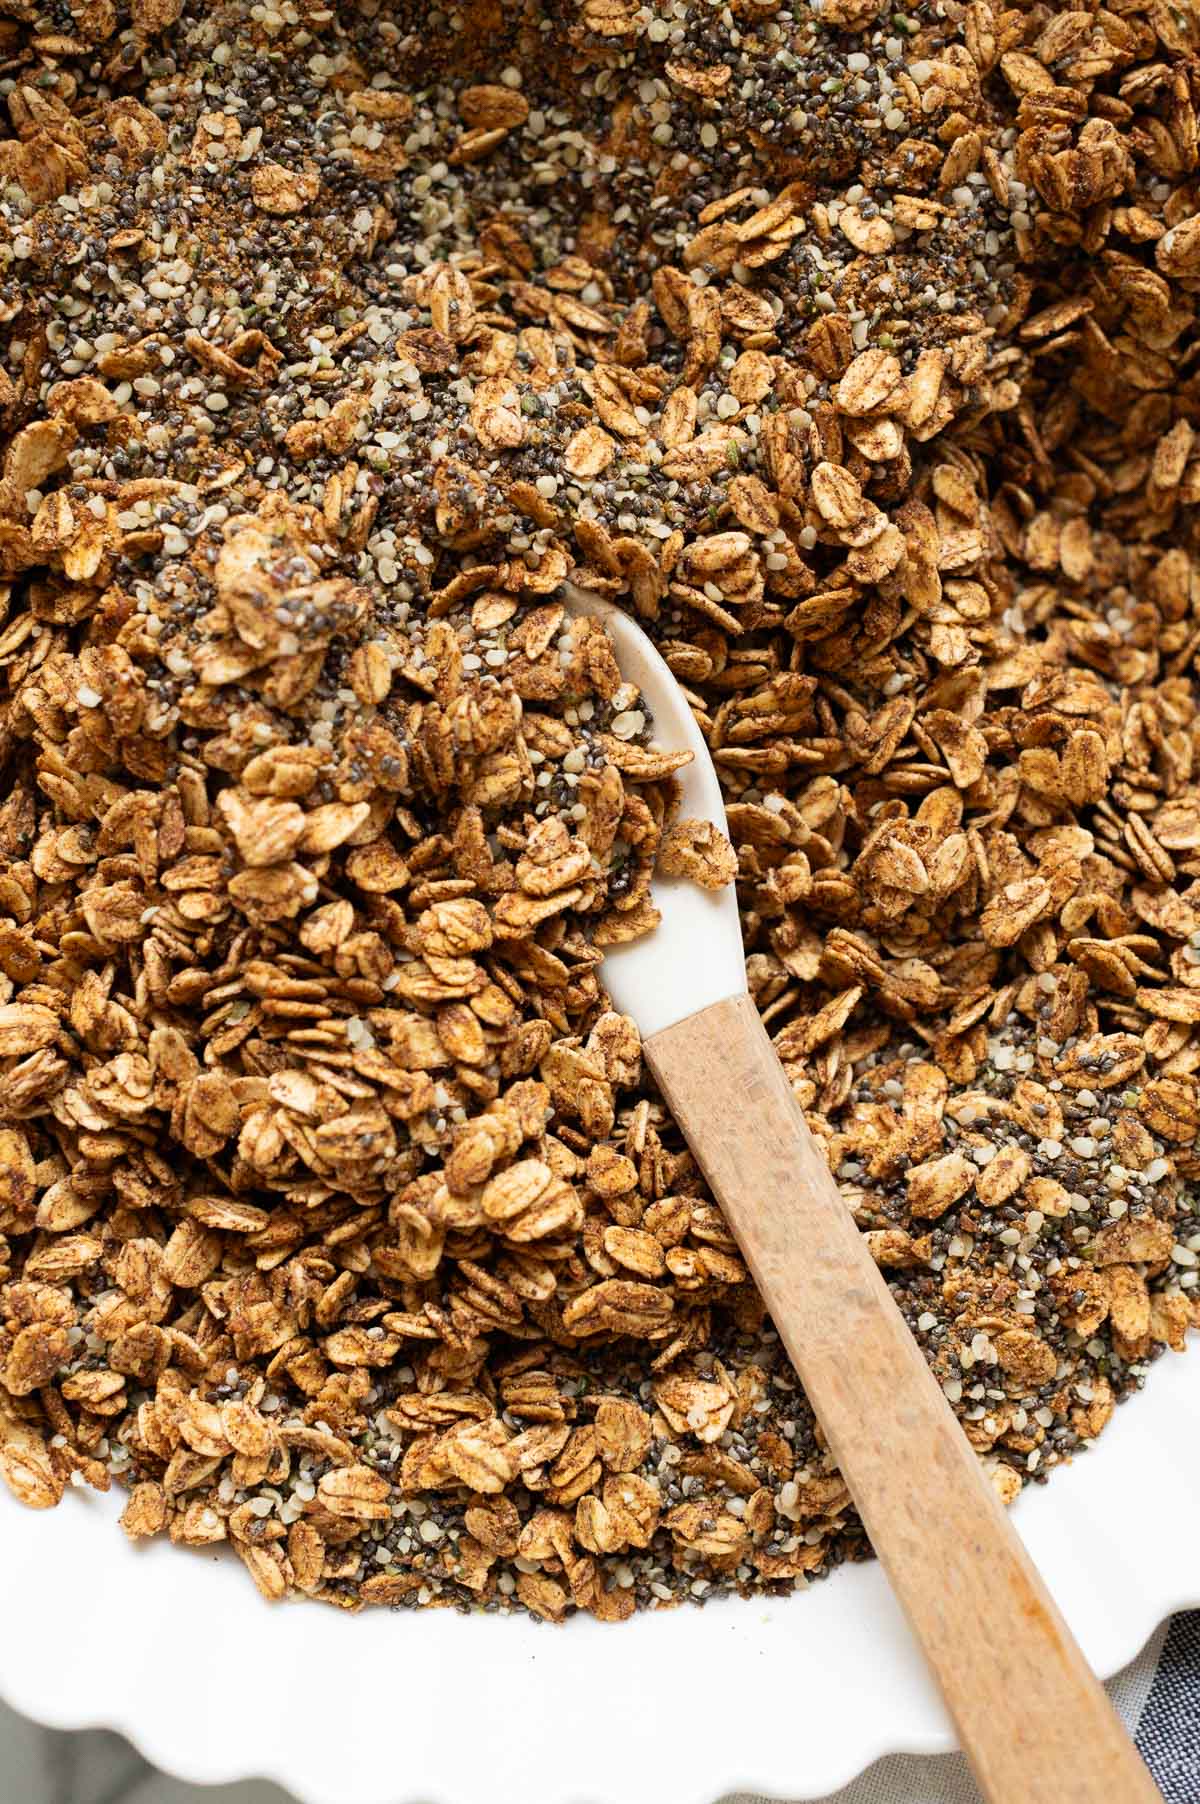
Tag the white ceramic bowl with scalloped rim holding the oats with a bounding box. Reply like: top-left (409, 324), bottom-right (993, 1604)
top-left (0, 1353), bottom-right (1200, 1804)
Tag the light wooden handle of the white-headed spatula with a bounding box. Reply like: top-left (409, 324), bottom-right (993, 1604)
top-left (646, 996), bottom-right (1160, 1804)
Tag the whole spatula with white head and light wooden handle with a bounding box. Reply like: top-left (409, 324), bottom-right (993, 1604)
top-left (567, 588), bottom-right (1158, 1804)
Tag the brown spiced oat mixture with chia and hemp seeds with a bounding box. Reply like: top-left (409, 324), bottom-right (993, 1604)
top-left (0, 0), bottom-right (1200, 1620)
